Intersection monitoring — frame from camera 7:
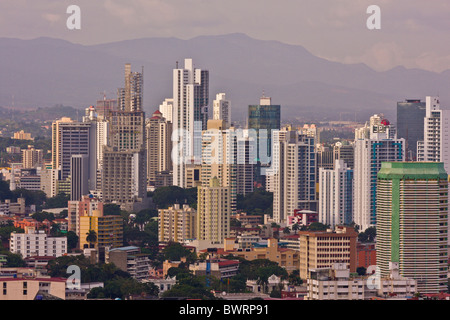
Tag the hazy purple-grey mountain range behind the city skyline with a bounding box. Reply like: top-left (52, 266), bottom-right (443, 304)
top-left (0, 34), bottom-right (450, 122)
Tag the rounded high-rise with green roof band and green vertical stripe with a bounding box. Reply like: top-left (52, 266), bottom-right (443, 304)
top-left (376, 162), bottom-right (448, 293)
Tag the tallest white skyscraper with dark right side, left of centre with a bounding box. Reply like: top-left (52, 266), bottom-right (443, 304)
top-left (172, 59), bottom-right (209, 187)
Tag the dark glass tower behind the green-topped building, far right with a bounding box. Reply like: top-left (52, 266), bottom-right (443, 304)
top-left (397, 100), bottom-right (426, 161)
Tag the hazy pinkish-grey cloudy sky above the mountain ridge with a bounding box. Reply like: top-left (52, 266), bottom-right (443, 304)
top-left (0, 0), bottom-right (450, 72)
